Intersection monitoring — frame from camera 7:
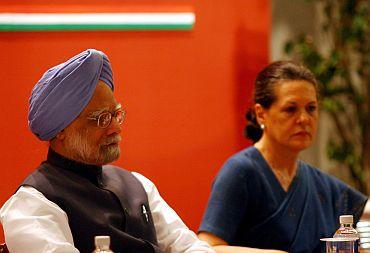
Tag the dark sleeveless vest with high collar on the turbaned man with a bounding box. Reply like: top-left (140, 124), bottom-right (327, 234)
top-left (22, 149), bottom-right (162, 253)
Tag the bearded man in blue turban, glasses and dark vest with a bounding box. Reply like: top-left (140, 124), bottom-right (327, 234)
top-left (0, 49), bottom-right (214, 253)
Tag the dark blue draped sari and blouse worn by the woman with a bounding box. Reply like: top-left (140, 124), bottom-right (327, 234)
top-left (199, 147), bottom-right (367, 252)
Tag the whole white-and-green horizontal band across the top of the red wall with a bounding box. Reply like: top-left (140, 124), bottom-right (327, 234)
top-left (0, 12), bottom-right (195, 31)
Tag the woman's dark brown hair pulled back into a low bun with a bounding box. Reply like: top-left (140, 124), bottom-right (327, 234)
top-left (245, 61), bottom-right (317, 143)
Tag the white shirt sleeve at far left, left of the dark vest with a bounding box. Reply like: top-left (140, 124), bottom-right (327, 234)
top-left (0, 186), bottom-right (79, 253)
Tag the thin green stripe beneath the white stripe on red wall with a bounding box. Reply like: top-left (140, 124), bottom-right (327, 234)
top-left (0, 24), bottom-right (193, 32)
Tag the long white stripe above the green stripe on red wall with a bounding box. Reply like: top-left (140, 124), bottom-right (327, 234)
top-left (0, 12), bottom-right (195, 25)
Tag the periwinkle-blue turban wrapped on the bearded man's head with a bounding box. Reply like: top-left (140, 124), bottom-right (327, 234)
top-left (28, 49), bottom-right (114, 141)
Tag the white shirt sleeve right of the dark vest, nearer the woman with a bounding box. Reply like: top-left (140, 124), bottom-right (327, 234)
top-left (132, 172), bottom-right (214, 253)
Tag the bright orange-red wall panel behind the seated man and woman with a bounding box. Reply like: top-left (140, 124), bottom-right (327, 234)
top-left (0, 0), bottom-right (270, 239)
